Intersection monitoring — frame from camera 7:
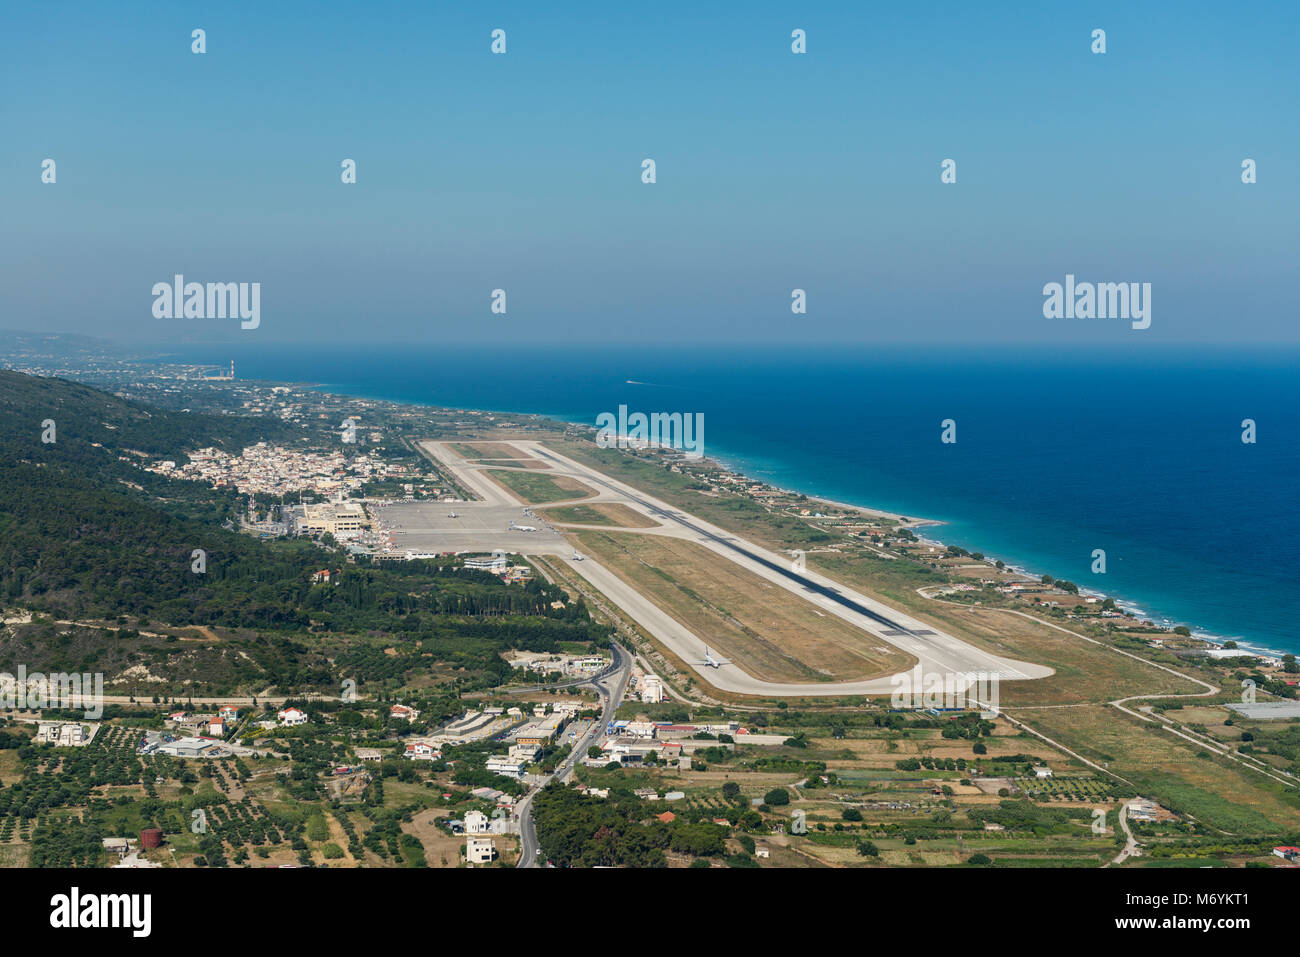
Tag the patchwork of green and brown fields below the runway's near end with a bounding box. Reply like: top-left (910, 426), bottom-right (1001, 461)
top-left (564, 705), bottom-right (1287, 867)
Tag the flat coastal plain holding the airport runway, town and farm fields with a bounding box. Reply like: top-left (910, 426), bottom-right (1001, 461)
top-left (0, 338), bottom-right (1300, 884)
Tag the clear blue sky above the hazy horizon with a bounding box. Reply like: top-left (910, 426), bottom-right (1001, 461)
top-left (0, 3), bottom-right (1300, 345)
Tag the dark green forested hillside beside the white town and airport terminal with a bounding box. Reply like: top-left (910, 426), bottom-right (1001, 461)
top-left (0, 372), bottom-right (606, 683)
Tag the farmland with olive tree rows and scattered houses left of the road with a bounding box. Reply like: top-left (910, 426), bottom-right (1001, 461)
top-left (0, 696), bottom-right (548, 867)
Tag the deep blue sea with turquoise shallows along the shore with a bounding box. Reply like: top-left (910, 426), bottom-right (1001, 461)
top-left (167, 343), bottom-right (1300, 653)
